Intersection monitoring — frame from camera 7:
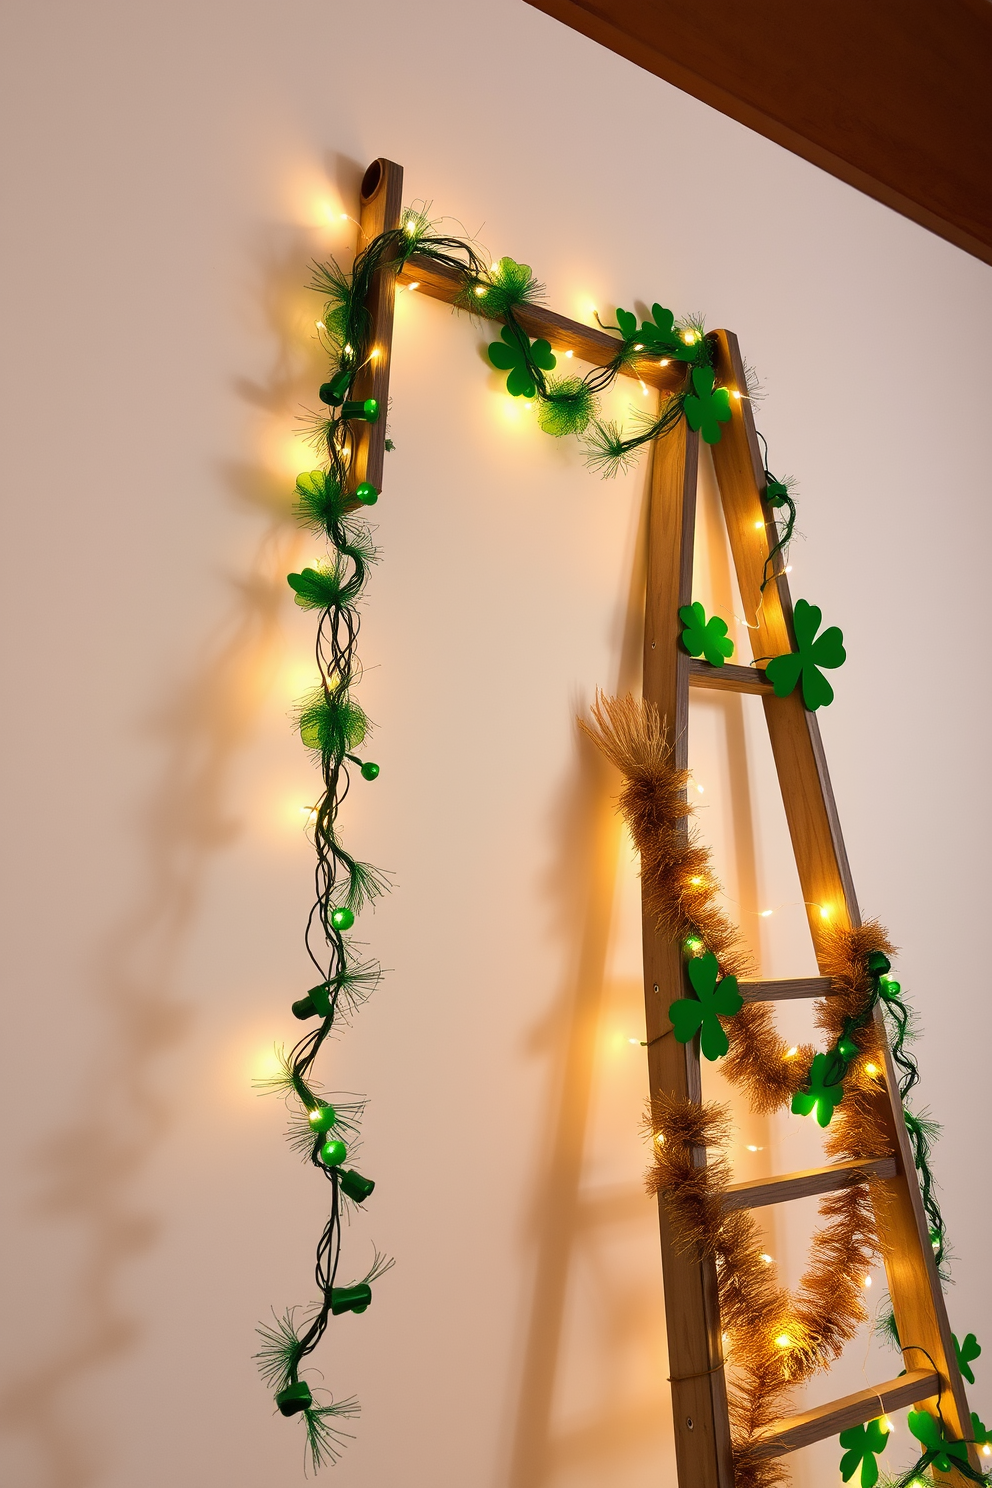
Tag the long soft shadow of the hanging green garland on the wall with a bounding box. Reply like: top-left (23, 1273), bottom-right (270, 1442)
top-left (0, 223), bottom-right (322, 1488)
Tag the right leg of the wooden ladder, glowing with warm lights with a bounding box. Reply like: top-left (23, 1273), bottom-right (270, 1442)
top-left (712, 330), bottom-right (979, 1485)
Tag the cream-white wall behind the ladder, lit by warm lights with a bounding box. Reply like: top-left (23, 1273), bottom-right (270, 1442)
top-left (0, 0), bottom-right (992, 1488)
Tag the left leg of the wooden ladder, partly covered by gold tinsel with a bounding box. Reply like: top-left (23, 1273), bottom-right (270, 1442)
top-left (642, 421), bottom-right (733, 1488)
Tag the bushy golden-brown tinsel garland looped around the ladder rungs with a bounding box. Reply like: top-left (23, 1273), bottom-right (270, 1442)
top-left (583, 696), bottom-right (894, 1488)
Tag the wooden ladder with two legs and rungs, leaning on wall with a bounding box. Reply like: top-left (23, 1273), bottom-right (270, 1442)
top-left (644, 330), bottom-right (977, 1488)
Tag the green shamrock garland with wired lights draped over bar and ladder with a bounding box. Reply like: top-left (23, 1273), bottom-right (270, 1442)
top-left (256, 205), bottom-right (992, 1488)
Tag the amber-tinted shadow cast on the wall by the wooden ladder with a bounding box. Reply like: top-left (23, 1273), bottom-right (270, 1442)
top-left (509, 440), bottom-right (757, 1488)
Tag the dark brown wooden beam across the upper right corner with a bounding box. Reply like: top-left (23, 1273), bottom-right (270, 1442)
top-left (528, 0), bottom-right (992, 263)
